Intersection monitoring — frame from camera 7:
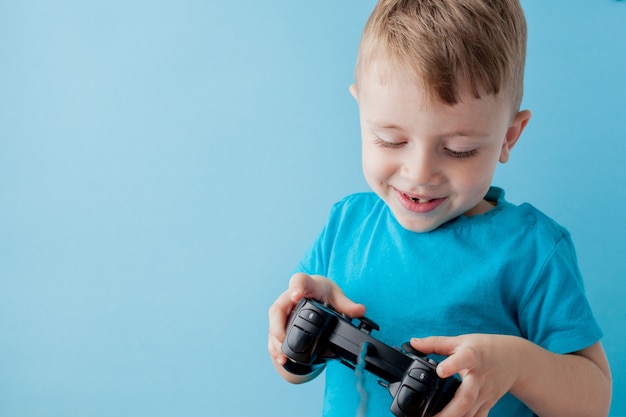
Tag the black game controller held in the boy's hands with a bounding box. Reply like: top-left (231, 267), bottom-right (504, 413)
top-left (282, 298), bottom-right (461, 417)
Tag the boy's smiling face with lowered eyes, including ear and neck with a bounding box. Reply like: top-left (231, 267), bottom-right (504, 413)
top-left (351, 66), bottom-right (530, 232)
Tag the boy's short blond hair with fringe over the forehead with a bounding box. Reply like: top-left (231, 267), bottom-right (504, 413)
top-left (355, 0), bottom-right (526, 110)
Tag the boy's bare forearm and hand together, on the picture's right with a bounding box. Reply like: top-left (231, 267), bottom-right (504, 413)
top-left (411, 334), bottom-right (612, 417)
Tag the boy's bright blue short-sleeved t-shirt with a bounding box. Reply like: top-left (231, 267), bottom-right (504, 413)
top-left (297, 187), bottom-right (602, 417)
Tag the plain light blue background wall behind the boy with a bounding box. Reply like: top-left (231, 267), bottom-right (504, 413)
top-left (0, 0), bottom-right (626, 417)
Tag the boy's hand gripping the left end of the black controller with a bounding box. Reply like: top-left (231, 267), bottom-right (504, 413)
top-left (268, 273), bottom-right (365, 382)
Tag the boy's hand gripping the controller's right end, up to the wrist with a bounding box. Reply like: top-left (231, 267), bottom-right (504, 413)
top-left (411, 334), bottom-right (526, 417)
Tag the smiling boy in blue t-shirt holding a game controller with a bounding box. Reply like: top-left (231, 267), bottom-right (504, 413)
top-left (268, 0), bottom-right (611, 417)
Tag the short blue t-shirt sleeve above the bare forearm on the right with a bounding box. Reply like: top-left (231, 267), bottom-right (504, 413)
top-left (519, 233), bottom-right (602, 354)
